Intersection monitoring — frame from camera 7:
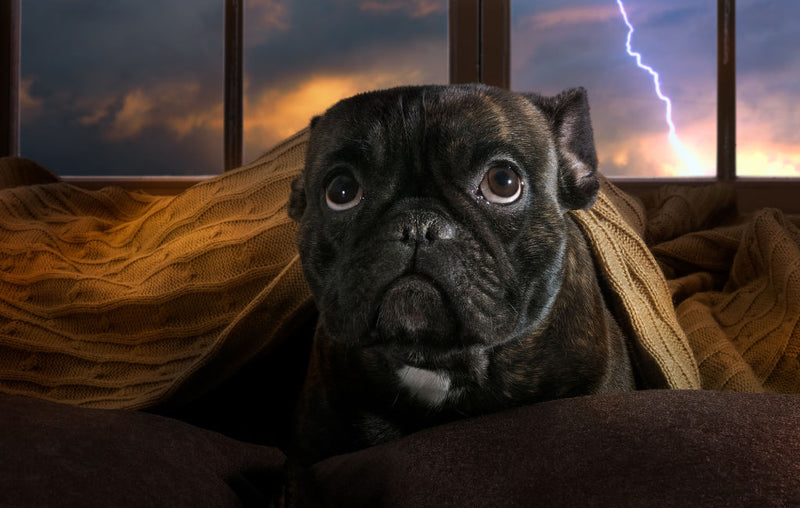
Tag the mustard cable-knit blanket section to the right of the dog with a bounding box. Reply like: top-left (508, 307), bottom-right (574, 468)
top-left (575, 181), bottom-right (800, 393)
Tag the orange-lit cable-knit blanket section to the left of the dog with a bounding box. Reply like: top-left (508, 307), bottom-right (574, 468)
top-left (0, 132), bottom-right (310, 408)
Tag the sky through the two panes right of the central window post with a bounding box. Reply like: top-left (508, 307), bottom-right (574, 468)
top-left (511, 0), bottom-right (800, 177)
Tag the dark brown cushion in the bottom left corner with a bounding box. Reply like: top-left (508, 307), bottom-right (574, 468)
top-left (0, 394), bottom-right (284, 508)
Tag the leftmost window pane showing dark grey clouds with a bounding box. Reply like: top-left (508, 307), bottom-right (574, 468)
top-left (20, 0), bottom-right (223, 175)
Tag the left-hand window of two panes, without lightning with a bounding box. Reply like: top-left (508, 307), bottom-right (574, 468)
top-left (9, 0), bottom-right (448, 176)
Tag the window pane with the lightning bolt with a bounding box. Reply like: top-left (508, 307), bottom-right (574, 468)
top-left (511, 0), bottom-right (717, 177)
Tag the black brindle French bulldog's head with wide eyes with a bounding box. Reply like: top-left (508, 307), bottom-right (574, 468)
top-left (289, 85), bottom-right (599, 359)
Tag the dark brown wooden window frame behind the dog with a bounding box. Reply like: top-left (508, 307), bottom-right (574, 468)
top-left (0, 0), bottom-right (800, 213)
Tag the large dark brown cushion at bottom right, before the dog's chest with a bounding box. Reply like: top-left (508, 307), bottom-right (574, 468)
top-left (314, 390), bottom-right (800, 507)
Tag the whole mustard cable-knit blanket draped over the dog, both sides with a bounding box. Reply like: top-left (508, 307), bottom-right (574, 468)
top-left (0, 131), bottom-right (800, 409)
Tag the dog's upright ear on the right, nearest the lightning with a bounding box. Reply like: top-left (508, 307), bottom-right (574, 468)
top-left (525, 88), bottom-right (600, 210)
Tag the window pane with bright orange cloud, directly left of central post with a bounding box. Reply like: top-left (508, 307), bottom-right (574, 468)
top-left (244, 0), bottom-right (448, 161)
